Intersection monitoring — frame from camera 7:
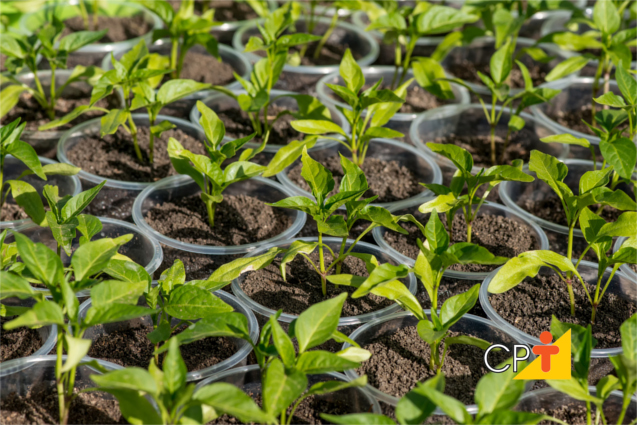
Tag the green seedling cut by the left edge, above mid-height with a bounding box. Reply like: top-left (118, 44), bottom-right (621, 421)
top-left (0, 118), bottom-right (80, 225)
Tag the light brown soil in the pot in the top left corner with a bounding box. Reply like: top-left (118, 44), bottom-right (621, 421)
top-left (64, 13), bottom-right (152, 43)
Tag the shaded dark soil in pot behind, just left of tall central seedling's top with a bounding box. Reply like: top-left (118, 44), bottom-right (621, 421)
top-left (217, 106), bottom-right (304, 145)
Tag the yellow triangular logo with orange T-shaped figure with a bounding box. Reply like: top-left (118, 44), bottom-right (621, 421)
top-left (513, 329), bottom-right (571, 380)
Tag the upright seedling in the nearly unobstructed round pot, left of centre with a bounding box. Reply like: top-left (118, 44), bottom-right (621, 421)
top-left (168, 101), bottom-right (266, 227)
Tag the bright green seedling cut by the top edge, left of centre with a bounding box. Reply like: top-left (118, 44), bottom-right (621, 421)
top-left (137, 0), bottom-right (221, 79)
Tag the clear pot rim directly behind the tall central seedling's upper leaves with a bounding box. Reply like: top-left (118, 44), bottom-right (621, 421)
top-left (316, 66), bottom-right (471, 143)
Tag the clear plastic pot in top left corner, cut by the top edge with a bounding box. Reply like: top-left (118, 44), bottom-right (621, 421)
top-left (20, 1), bottom-right (163, 66)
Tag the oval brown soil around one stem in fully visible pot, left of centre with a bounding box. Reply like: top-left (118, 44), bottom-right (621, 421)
top-left (145, 195), bottom-right (291, 246)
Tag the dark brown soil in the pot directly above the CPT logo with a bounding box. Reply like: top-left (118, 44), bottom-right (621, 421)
top-left (489, 275), bottom-right (637, 348)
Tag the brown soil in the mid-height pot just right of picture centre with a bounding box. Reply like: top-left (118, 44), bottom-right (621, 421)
top-left (384, 212), bottom-right (540, 273)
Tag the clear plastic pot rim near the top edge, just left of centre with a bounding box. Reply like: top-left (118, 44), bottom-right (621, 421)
top-left (232, 18), bottom-right (378, 69)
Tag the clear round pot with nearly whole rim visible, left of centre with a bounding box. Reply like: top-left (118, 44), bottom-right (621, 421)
top-left (133, 175), bottom-right (306, 255)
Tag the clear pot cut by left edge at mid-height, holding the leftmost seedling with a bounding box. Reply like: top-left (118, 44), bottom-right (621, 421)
top-left (0, 155), bottom-right (82, 230)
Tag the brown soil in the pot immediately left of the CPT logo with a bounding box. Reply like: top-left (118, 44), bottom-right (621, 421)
top-left (356, 326), bottom-right (508, 404)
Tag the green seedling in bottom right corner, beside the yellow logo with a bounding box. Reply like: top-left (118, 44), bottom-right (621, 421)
top-left (546, 314), bottom-right (637, 425)
